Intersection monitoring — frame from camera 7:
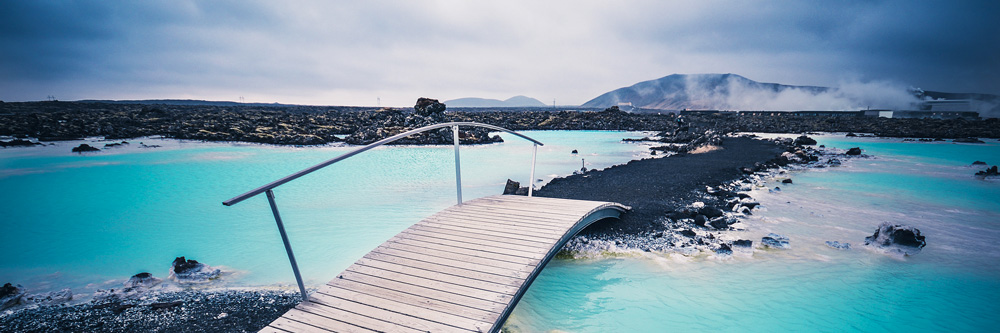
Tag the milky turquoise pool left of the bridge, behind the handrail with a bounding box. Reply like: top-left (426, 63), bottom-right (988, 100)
top-left (0, 131), bottom-right (647, 293)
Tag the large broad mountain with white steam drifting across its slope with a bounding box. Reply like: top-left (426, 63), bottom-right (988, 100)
top-left (582, 74), bottom-right (830, 110)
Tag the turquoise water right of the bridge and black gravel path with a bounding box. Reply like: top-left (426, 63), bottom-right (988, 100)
top-left (508, 135), bottom-right (1000, 332)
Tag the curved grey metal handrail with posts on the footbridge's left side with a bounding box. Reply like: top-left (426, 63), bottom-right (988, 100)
top-left (222, 122), bottom-right (545, 301)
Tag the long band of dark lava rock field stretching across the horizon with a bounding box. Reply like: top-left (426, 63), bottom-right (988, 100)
top-left (0, 100), bottom-right (1000, 147)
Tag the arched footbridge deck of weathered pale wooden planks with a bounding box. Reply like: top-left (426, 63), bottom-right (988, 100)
top-left (262, 195), bottom-right (628, 332)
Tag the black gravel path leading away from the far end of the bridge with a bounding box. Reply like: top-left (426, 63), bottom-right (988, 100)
top-left (535, 138), bottom-right (784, 234)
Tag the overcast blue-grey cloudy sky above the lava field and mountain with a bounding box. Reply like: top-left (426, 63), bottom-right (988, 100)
top-left (0, 0), bottom-right (1000, 106)
